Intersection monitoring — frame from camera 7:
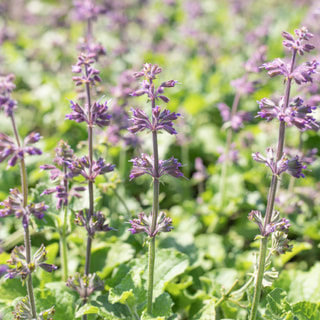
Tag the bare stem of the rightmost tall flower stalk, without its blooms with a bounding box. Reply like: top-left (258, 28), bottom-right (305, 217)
top-left (250, 50), bottom-right (297, 320)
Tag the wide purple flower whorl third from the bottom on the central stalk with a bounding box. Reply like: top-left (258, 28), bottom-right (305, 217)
top-left (128, 106), bottom-right (180, 134)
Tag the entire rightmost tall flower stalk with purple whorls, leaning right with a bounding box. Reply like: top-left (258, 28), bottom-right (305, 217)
top-left (249, 27), bottom-right (319, 320)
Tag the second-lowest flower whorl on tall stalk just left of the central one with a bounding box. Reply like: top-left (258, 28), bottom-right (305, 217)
top-left (75, 209), bottom-right (115, 238)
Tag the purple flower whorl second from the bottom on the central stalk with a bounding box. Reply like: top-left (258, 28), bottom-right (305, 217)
top-left (130, 153), bottom-right (183, 180)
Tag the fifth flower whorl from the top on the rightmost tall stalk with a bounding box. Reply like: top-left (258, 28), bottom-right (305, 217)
top-left (248, 210), bottom-right (290, 236)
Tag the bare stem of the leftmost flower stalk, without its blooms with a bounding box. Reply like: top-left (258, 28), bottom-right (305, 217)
top-left (10, 115), bottom-right (37, 319)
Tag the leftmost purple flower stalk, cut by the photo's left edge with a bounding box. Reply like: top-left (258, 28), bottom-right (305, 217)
top-left (0, 75), bottom-right (56, 319)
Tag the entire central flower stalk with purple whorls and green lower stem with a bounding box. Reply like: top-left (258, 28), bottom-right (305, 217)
top-left (128, 63), bottom-right (183, 314)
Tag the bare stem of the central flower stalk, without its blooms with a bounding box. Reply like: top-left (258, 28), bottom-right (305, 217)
top-left (147, 84), bottom-right (160, 314)
